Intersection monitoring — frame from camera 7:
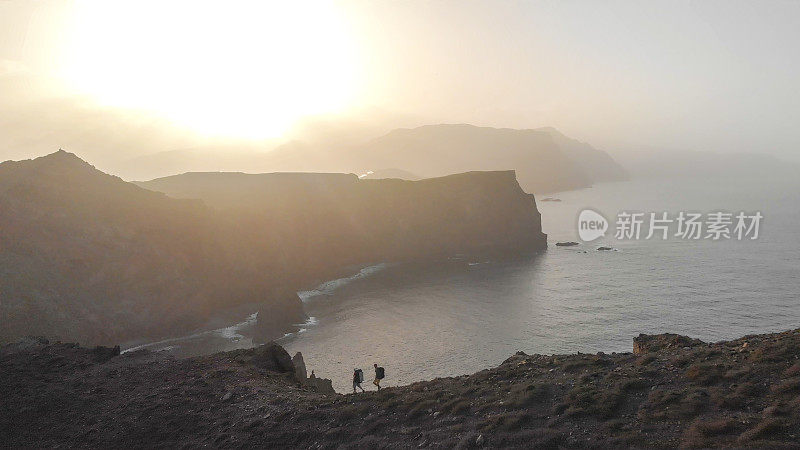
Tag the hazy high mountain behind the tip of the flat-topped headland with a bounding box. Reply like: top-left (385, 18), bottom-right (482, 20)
top-left (346, 124), bottom-right (627, 193)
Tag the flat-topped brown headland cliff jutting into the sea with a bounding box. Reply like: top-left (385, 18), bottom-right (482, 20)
top-left (140, 171), bottom-right (546, 284)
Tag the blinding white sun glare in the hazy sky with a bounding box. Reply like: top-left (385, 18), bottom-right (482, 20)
top-left (60, 0), bottom-right (358, 139)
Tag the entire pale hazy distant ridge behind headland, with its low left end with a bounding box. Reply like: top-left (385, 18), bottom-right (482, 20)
top-left (117, 124), bottom-right (628, 193)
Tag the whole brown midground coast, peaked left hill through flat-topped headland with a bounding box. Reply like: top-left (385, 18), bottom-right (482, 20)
top-left (0, 152), bottom-right (544, 344)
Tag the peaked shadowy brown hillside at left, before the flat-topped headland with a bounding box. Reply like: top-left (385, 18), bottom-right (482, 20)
top-left (0, 151), bottom-right (252, 343)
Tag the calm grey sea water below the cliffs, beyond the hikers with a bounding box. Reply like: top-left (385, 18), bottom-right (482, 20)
top-left (125, 174), bottom-right (800, 392)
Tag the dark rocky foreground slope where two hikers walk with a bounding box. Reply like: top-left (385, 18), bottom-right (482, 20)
top-left (0, 330), bottom-right (800, 448)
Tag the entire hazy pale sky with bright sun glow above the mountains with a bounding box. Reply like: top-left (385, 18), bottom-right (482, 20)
top-left (0, 0), bottom-right (800, 165)
